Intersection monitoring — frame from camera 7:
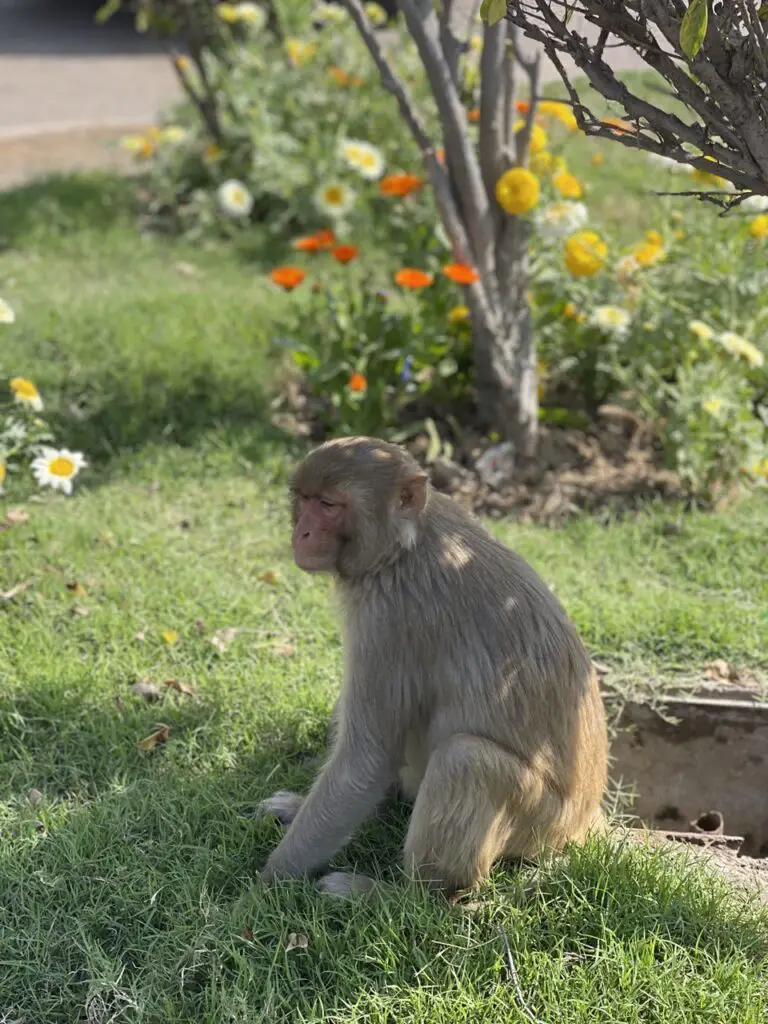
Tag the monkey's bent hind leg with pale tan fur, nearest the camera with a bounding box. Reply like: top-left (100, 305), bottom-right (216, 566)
top-left (403, 734), bottom-right (562, 892)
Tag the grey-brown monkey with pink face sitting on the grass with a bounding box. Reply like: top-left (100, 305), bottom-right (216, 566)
top-left (260, 437), bottom-right (607, 895)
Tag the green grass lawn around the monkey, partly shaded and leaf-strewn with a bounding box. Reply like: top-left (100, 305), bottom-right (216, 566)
top-left (0, 169), bottom-right (768, 1024)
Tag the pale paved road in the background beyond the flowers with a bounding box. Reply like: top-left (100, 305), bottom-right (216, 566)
top-left (0, 0), bottom-right (640, 187)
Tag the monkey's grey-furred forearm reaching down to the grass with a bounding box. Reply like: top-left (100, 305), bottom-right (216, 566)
top-left (261, 709), bottom-right (396, 883)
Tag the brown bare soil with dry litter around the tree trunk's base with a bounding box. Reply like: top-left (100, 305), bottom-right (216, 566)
top-left (272, 379), bottom-right (685, 528)
